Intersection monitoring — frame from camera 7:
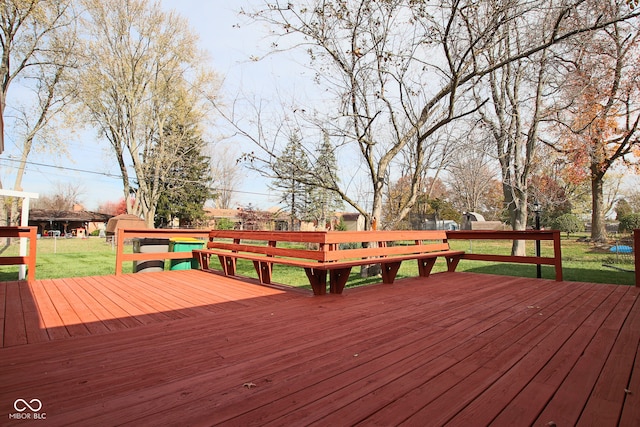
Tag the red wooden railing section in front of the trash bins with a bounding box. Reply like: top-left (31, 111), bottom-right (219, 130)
top-left (115, 228), bottom-right (210, 276)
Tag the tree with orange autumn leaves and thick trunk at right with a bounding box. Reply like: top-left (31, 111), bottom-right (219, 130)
top-left (550, 20), bottom-right (640, 241)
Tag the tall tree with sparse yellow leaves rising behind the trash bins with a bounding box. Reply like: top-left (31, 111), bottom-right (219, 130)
top-left (78, 0), bottom-right (215, 227)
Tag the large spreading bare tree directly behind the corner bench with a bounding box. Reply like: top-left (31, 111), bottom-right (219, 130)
top-left (222, 0), bottom-right (637, 231)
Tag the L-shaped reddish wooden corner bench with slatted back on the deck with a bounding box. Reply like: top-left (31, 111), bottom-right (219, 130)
top-left (193, 230), bottom-right (464, 295)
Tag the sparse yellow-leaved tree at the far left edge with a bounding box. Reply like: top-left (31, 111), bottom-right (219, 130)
top-left (0, 0), bottom-right (77, 226)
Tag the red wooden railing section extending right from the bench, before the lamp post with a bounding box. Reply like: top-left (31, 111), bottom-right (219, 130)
top-left (447, 230), bottom-right (562, 281)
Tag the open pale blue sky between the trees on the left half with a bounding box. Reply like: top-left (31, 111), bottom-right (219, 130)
top-left (0, 0), bottom-right (291, 210)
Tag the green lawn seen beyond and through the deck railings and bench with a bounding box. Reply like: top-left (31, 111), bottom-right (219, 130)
top-left (0, 232), bottom-right (635, 287)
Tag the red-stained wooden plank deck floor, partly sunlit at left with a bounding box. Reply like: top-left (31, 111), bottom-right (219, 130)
top-left (0, 271), bottom-right (640, 426)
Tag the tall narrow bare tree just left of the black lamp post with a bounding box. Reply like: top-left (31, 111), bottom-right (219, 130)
top-left (475, 5), bottom-right (559, 255)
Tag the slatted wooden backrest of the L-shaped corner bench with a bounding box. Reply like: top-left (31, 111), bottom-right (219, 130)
top-left (207, 230), bottom-right (449, 262)
